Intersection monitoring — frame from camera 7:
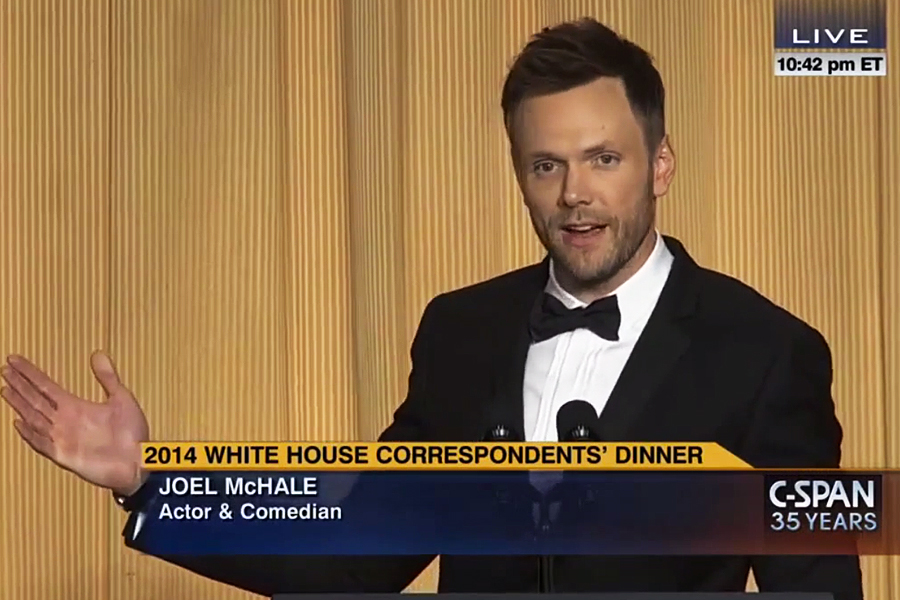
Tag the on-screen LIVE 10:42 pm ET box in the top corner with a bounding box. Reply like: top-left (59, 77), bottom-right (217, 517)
top-left (775, 0), bottom-right (887, 77)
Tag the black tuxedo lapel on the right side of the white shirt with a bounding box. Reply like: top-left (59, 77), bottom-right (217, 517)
top-left (598, 236), bottom-right (699, 442)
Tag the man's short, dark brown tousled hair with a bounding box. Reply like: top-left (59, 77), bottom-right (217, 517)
top-left (500, 18), bottom-right (666, 152)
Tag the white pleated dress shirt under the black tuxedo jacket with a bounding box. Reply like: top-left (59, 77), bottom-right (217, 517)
top-left (523, 232), bottom-right (673, 442)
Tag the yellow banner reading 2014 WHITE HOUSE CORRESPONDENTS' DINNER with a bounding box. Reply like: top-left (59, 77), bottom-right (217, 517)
top-left (142, 442), bottom-right (752, 471)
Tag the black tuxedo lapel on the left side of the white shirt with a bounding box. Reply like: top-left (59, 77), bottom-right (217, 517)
top-left (493, 258), bottom-right (549, 440)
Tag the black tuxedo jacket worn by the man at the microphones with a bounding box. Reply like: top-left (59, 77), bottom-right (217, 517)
top-left (125, 237), bottom-right (862, 600)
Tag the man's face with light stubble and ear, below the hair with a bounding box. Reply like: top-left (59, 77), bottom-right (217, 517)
top-left (512, 78), bottom-right (674, 294)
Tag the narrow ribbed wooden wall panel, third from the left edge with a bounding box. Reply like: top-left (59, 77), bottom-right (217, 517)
top-left (278, 0), bottom-right (359, 440)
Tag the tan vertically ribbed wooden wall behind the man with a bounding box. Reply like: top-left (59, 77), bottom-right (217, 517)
top-left (0, 0), bottom-right (900, 600)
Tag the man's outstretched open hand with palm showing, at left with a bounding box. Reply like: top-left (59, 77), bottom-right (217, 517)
top-left (0, 352), bottom-right (149, 495)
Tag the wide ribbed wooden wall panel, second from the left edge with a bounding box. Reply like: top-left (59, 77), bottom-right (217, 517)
top-left (105, 0), bottom-right (288, 600)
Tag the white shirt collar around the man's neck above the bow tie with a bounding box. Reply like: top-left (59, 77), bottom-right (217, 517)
top-left (544, 231), bottom-right (674, 329)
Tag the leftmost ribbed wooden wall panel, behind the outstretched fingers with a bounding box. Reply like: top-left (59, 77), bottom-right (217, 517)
top-left (0, 0), bottom-right (111, 600)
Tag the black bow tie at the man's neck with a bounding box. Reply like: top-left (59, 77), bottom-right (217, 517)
top-left (529, 294), bottom-right (622, 343)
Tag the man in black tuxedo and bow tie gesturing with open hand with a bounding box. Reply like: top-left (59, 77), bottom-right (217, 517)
top-left (3, 20), bottom-right (862, 600)
